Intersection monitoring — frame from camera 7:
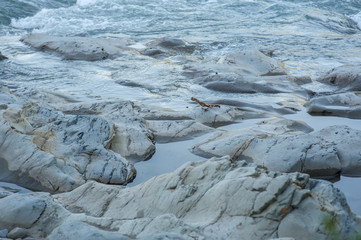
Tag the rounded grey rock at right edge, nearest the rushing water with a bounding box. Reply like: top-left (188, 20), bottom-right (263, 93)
top-left (317, 65), bottom-right (361, 92)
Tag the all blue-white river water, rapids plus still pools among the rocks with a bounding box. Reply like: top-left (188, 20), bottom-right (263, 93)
top-left (0, 0), bottom-right (361, 214)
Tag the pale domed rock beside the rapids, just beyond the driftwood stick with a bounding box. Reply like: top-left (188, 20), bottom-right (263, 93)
top-left (183, 50), bottom-right (310, 97)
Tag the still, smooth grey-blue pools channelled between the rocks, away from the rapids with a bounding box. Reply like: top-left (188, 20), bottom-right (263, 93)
top-left (128, 110), bottom-right (361, 215)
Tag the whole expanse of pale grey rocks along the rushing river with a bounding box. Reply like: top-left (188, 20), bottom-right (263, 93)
top-left (0, 34), bottom-right (361, 240)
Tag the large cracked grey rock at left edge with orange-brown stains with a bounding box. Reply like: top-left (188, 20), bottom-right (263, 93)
top-left (0, 87), bottom-right (136, 192)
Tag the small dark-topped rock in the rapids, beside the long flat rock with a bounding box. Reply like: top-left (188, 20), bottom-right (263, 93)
top-left (140, 37), bottom-right (195, 57)
